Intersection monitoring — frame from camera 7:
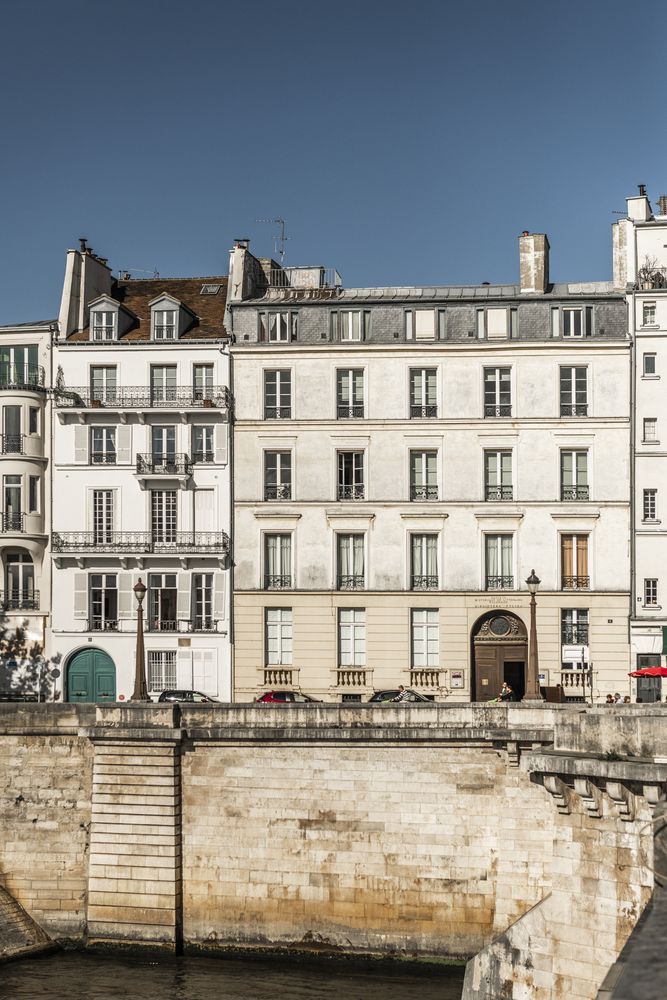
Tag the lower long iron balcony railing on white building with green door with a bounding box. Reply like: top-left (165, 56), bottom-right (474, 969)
top-left (51, 529), bottom-right (229, 555)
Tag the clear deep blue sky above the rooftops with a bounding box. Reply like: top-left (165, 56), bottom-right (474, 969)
top-left (0, 0), bottom-right (667, 323)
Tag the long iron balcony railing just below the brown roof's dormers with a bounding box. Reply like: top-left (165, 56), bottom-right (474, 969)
top-left (54, 385), bottom-right (231, 410)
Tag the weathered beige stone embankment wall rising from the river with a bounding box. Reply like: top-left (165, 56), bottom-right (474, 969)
top-left (0, 704), bottom-right (667, 1000)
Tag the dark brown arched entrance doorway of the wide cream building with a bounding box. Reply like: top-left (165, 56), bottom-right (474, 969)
top-left (472, 610), bottom-right (528, 701)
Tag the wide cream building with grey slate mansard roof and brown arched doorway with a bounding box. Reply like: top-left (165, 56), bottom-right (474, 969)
top-left (226, 233), bottom-right (631, 701)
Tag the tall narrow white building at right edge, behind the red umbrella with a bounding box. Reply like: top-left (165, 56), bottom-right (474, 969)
top-left (613, 185), bottom-right (667, 701)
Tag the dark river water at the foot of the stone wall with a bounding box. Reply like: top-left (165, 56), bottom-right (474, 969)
top-left (0, 952), bottom-right (463, 1000)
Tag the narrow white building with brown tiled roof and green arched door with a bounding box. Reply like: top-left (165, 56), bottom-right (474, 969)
top-left (50, 242), bottom-right (231, 701)
